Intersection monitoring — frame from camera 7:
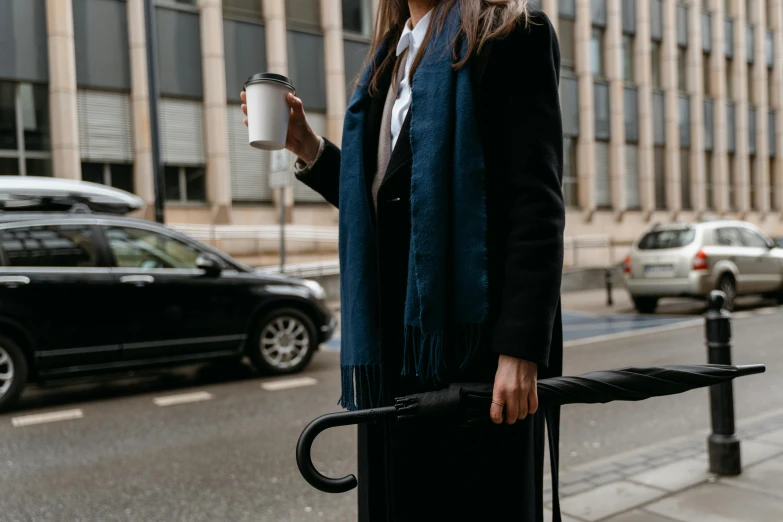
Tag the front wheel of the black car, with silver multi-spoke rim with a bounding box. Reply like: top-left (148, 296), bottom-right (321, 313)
top-left (247, 308), bottom-right (318, 375)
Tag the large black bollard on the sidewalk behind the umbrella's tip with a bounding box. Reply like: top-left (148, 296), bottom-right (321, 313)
top-left (705, 290), bottom-right (742, 475)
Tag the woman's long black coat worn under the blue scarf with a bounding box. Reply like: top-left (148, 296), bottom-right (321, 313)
top-left (300, 12), bottom-right (565, 522)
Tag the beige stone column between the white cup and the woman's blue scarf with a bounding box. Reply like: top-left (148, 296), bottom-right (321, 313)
top-left (321, 0), bottom-right (346, 143)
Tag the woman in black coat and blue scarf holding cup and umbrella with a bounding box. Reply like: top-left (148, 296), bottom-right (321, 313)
top-left (243, 0), bottom-right (564, 522)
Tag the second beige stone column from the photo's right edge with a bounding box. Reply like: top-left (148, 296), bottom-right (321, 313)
top-left (749, 1), bottom-right (769, 215)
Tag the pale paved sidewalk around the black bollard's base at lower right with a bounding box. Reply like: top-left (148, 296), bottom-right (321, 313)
top-left (545, 411), bottom-right (783, 522)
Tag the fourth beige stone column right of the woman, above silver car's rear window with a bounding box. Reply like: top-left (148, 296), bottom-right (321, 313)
top-left (661, 0), bottom-right (682, 211)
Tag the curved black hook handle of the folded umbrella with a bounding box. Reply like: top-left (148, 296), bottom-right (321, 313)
top-left (296, 406), bottom-right (397, 493)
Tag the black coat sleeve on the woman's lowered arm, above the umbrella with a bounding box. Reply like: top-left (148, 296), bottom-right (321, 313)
top-left (487, 12), bottom-right (565, 366)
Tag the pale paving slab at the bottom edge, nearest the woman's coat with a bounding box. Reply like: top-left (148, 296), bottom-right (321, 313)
top-left (560, 481), bottom-right (664, 522)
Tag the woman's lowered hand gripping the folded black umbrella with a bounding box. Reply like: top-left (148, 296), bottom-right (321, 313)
top-left (489, 355), bottom-right (538, 424)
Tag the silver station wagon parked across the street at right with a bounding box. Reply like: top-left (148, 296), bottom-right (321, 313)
top-left (624, 220), bottom-right (783, 313)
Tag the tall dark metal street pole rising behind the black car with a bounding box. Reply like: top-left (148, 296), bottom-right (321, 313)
top-left (144, 0), bottom-right (166, 223)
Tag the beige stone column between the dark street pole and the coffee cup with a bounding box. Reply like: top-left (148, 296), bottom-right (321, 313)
top-left (199, 0), bottom-right (231, 223)
